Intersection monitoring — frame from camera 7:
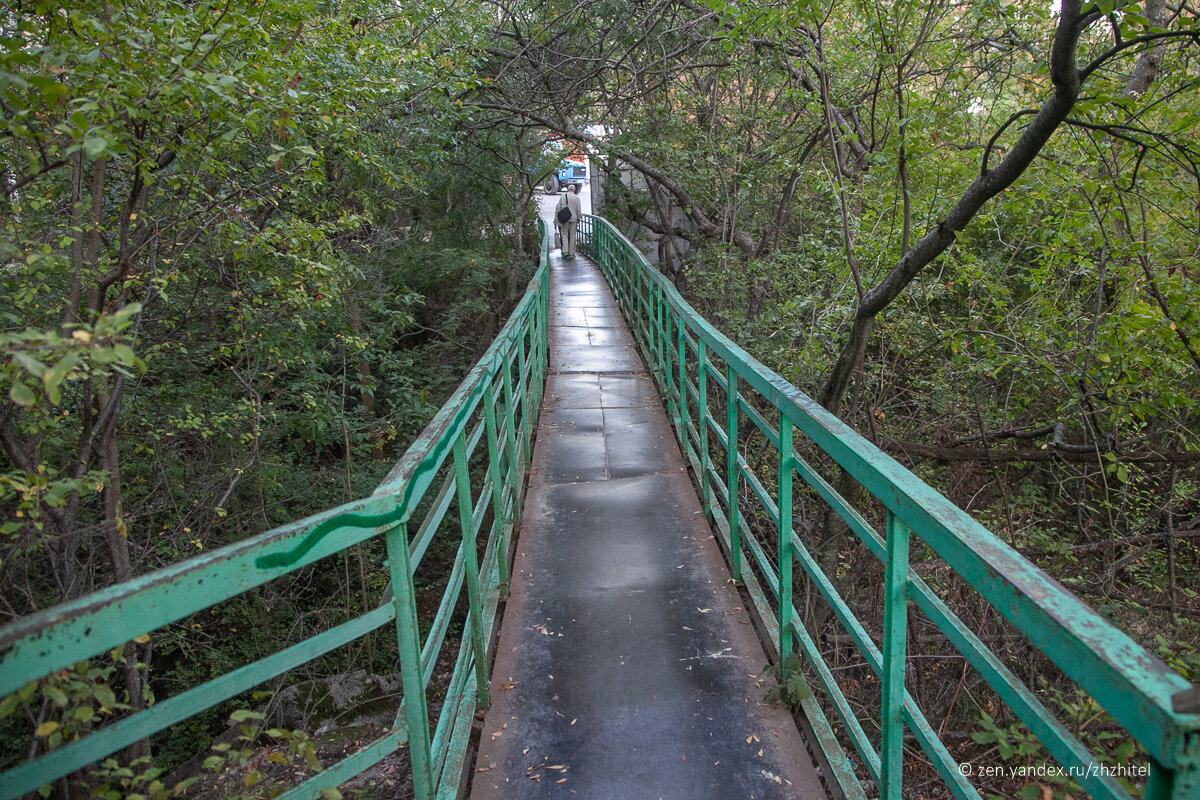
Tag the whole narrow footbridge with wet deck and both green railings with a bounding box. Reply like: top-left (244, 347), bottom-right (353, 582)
top-left (0, 216), bottom-right (1200, 800)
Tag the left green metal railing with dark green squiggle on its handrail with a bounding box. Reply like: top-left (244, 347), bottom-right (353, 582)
top-left (0, 223), bottom-right (550, 800)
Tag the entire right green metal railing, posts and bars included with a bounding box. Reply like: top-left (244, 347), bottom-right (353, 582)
top-left (580, 216), bottom-right (1200, 800)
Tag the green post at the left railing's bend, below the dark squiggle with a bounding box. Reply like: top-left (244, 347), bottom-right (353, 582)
top-left (384, 523), bottom-right (433, 800)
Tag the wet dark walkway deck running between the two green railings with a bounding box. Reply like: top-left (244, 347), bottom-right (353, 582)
top-left (470, 215), bottom-right (826, 800)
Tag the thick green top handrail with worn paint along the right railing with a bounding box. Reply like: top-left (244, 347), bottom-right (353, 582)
top-left (578, 218), bottom-right (1200, 768)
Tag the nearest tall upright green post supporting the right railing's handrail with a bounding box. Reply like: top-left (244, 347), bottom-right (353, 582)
top-left (880, 511), bottom-right (910, 800)
